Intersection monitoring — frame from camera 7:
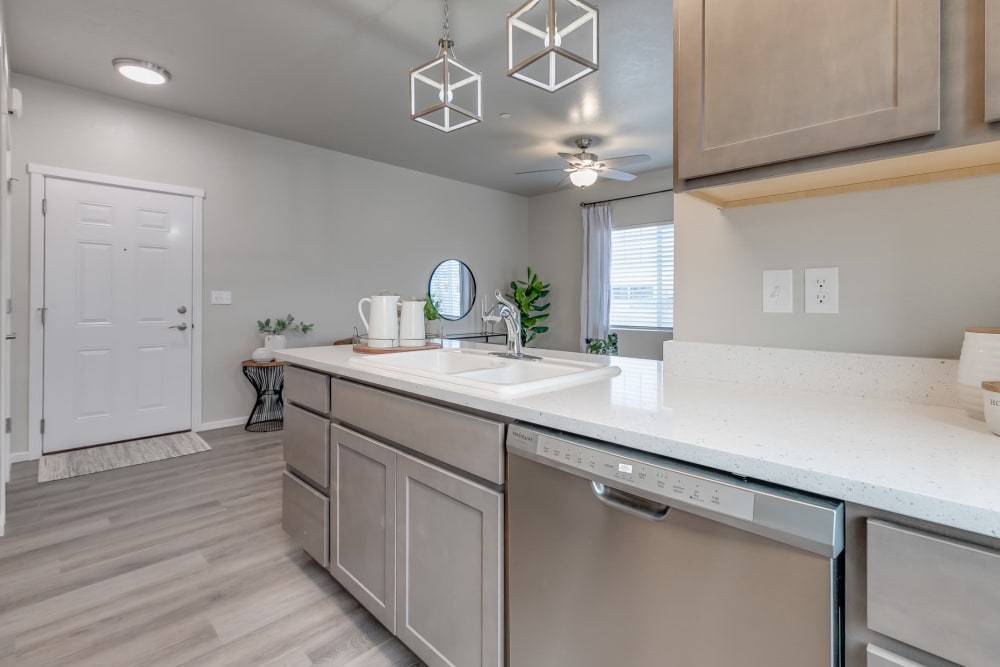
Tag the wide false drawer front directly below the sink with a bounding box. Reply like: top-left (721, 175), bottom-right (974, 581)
top-left (331, 380), bottom-right (504, 484)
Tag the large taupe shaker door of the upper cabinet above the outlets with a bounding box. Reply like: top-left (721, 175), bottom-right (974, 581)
top-left (674, 0), bottom-right (941, 179)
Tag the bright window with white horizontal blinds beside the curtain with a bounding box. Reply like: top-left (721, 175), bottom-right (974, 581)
top-left (611, 223), bottom-right (674, 329)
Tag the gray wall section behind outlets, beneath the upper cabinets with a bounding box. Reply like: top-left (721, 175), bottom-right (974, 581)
top-left (674, 175), bottom-right (1000, 358)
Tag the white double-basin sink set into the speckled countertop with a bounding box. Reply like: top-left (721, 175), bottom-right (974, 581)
top-left (351, 348), bottom-right (621, 397)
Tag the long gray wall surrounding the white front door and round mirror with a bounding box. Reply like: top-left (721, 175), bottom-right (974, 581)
top-left (13, 76), bottom-right (528, 451)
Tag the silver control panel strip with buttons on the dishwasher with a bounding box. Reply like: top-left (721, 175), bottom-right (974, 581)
top-left (535, 434), bottom-right (755, 521)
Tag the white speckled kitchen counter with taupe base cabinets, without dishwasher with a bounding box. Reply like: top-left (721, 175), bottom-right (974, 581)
top-left (276, 343), bottom-right (1000, 667)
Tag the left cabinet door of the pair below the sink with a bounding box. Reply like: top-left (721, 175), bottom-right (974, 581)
top-left (330, 426), bottom-right (396, 630)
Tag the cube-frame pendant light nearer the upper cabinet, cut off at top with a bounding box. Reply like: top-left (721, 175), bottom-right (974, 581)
top-left (507, 0), bottom-right (597, 93)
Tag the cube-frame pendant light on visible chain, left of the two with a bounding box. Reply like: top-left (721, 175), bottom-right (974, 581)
top-left (410, 0), bottom-right (483, 132)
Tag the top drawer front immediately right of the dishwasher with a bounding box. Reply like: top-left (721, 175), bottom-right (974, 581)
top-left (867, 520), bottom-right (1000, 666)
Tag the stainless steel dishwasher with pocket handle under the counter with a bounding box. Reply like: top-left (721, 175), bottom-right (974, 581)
top-left (507, 424), bottom-right (844, 667)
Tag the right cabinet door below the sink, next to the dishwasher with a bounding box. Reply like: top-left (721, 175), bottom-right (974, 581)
top-left (396, 454), bottom-right (503, 667)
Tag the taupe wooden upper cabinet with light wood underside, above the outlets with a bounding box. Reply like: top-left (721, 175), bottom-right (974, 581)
top-left (674, 0), bottom-right (1000, 207)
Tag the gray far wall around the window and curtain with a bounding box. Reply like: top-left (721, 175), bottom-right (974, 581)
top-left (522, 169), bottom-right (673, 359)
